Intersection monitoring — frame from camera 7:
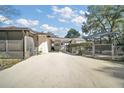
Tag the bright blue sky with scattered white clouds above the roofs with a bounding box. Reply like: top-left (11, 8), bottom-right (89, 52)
top-left (0, 5), bottom-right (88, 37)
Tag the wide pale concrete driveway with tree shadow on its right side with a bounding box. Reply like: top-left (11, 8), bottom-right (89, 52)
top-left (0, 53), bottom-right (124, 88)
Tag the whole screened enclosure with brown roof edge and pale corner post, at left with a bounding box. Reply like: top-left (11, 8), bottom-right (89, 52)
top-left (0, 27), bottom-right (37, 59)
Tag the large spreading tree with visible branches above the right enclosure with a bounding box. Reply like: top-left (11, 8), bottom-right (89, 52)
top-left (82, 5), bottom-right (124, 42)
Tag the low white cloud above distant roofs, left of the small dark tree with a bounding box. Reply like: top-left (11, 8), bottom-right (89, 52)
top-left (40, 24), bottom-right (69, 37)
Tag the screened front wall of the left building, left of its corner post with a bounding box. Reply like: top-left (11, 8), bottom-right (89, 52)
top-left (0, 31), bottom-right (23, 58)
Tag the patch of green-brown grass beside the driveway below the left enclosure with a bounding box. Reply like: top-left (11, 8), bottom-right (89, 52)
top-left (0, 59), bottom-right (20, 70)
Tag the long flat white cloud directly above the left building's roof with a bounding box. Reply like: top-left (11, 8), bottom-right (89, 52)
top-left (16, 18), bottom-right (39, 27)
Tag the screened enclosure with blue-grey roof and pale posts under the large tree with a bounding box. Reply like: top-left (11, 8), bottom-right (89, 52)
top-left (82, 32), bottom-right (124, 60)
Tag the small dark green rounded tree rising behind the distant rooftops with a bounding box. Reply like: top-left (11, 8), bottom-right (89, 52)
top-left (65, 28), bottom-right (80, 38)
